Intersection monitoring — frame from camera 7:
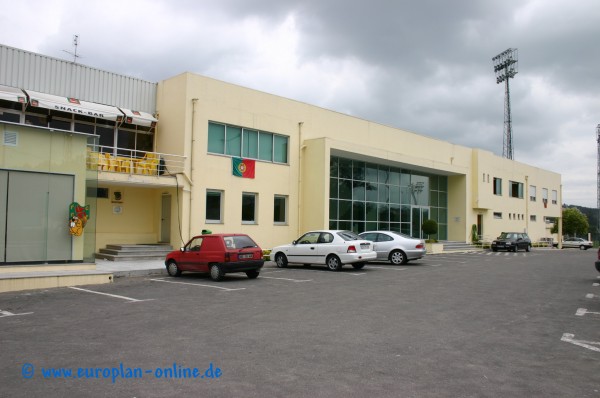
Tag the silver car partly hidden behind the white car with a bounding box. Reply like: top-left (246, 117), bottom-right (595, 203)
top-left (359, 231), bottom-right (425, 265)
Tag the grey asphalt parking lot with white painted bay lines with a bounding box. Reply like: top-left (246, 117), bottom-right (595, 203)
top-left (0, 250), bottom-right (600, 397)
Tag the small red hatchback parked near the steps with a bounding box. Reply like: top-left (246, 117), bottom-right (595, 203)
top-left (165, 234), bottom-right (265, 281)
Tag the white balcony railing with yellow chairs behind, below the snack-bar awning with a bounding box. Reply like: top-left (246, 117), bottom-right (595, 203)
top-left (86, 144), bottom-right (185, 175)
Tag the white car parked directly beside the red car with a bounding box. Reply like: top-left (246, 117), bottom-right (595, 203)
top-left (270, 230), bottom-right (377, 271)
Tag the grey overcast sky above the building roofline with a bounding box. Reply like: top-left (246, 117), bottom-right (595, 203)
top-left (0, 0), bottom-right (600, 207)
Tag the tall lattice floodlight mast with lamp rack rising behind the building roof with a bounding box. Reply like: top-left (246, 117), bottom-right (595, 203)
top-left (492, 48), bottom-right (518, 159)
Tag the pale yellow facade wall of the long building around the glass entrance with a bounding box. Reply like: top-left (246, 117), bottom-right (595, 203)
top-left (157, 73), bottom-right (561, 248)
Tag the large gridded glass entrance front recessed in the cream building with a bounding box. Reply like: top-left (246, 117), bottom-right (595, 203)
top-left (329, 156), bottom-right (448, 240)
